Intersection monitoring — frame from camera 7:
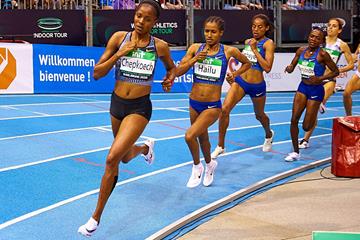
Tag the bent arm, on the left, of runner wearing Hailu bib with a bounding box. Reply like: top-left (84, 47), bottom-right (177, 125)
top-left (176, 44), bottom-right (207, 76)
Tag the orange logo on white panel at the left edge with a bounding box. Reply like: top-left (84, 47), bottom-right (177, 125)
top-left (0, 48), bottom-right (16, 89)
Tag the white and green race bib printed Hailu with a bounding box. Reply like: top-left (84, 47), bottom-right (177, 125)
top-left (194, 57), bottom-right (222, 82)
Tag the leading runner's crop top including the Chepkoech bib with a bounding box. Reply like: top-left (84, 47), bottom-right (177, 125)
top-left (115, 33), bottom-right (157, 85)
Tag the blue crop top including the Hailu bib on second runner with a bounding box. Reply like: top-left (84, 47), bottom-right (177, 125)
top-left (194, 44), bottom-right (227, 85)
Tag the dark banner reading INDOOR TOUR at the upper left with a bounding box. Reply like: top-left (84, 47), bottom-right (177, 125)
top-left (0, 10), bottom-right (86, 45)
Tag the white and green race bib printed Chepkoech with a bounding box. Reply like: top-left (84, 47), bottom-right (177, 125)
top-left (120, 49), bottom-right (156, 81)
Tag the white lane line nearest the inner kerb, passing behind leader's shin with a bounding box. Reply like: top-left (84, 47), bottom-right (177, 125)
top-left (0, 134), bottom-right (331, 230)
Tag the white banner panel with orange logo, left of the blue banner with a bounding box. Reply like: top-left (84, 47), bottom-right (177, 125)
top-left (0, 43), bottom-right (34, 94)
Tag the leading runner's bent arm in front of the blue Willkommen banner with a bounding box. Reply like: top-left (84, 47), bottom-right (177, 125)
top-left (93, 32), bottom-right (136, 80)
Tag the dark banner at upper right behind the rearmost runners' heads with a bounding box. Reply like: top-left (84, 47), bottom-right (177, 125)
top-left (281, 10), bottom-right (352, 43)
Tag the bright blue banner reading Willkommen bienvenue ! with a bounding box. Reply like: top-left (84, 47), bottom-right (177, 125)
top-left (33, 45), bottom-right (115, 93)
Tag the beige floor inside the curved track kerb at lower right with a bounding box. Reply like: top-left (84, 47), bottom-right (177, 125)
top-left (178, 166), bottom-right (360, 240)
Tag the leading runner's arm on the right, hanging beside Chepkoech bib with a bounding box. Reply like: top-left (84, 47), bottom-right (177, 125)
top-left (155, 38), bottom-right (176, 92)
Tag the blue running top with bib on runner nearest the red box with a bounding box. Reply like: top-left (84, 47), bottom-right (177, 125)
top-left (298, 48), bottom-right (325, 79)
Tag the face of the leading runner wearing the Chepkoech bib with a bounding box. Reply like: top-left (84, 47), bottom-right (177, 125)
top-left (134, 4), bottom-right (157, 35)
